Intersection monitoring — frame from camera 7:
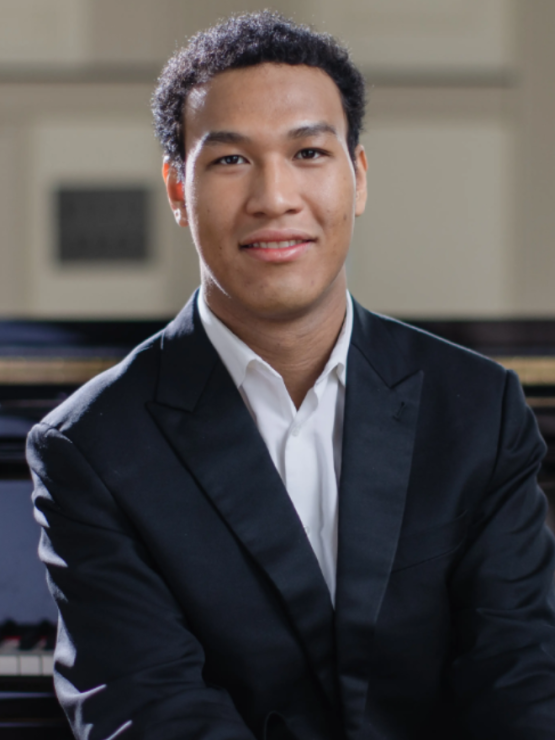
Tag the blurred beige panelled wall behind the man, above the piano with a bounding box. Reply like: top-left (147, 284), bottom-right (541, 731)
top-left (0, 0), bottom-right (555, 318)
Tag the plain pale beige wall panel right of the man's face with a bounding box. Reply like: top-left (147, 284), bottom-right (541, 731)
top-left (349, 116), bottom-right (513, 317)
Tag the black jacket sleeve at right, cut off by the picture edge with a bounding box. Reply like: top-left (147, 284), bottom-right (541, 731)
top-left (450, 372), bottom-right (555, 740)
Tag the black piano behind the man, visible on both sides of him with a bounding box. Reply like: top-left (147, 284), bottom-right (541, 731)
top-left (0, 320), bottom-right (555, 740)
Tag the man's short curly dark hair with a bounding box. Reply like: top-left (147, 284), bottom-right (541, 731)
top-left (151, 10), bottom-right (366, 174)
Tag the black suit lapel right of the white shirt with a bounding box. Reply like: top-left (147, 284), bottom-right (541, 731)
top-left (336, 304), bottom-right (422, 737)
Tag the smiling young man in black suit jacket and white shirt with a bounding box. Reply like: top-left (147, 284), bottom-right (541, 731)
top-left (29, 13), bottom-right (555, 740)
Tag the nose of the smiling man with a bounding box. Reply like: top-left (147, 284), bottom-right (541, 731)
top-left (247, 157), bottom-right (302, 218)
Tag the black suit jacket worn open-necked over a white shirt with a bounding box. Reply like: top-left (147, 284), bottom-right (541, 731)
top-left (28, 301), bottom-right (555, 740)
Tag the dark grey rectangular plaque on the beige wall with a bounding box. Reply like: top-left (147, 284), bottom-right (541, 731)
top-left (57, 187), bottom-right (150, 264)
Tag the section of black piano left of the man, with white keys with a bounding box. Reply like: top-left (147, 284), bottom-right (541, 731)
top-left (0, 321), bottom-right (166, 740)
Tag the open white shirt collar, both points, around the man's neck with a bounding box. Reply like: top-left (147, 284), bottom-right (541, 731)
top-left (197, 286), bottom-right (353, 388)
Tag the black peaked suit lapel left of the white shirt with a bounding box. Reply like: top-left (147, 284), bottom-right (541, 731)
top-left (149, 299), bottom-right (336, 704)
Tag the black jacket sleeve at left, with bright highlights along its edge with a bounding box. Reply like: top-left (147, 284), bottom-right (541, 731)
top-left (27, 424), bottom-right (260, 740)
